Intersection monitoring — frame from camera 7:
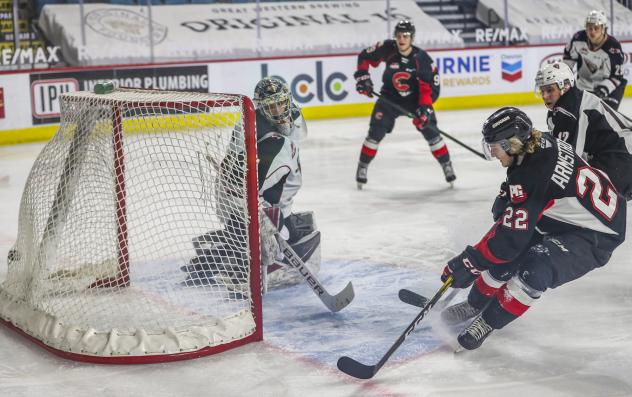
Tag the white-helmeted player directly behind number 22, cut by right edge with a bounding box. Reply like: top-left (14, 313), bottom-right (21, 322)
top-left (535, 63), bottom-right (632, 200)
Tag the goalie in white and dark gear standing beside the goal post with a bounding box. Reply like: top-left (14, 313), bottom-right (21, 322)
top-left (182, 77), bottom-right (320, 293)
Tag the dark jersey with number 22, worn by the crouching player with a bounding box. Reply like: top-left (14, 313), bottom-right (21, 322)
top-left (470, 134), bottom-right (626, 268)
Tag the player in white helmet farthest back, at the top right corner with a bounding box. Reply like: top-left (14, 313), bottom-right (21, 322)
top-left (563, 10), bottom-right (627, 110)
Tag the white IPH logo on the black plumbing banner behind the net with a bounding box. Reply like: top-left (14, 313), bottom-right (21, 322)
top-left (31, 79), bottom-right (79, 119)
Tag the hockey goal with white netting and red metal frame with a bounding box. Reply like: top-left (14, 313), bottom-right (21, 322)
top-left (0, 88), bottom-right (262, 363)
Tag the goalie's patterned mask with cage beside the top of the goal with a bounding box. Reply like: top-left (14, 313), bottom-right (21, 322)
top-left (253, 77), bottom-right (293, 124)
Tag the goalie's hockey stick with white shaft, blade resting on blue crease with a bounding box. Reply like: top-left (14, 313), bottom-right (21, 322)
top-left (262, 214), bottom-right (355, 313)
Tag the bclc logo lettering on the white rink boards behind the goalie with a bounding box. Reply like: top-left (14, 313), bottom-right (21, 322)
top-left (261, 61), bottom-right (349, 103)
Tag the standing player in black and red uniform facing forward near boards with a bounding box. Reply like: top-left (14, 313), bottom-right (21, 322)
top-left (354, 20), bottom-right (456, 188)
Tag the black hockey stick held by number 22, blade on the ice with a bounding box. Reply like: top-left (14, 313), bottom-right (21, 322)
top-left (338, 276), bottom-right (452, 379)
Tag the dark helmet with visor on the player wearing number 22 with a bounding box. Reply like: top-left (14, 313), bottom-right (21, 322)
top-left (482, 107), bottom-right (533, 160)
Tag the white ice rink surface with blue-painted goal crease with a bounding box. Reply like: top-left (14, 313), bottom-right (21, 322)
top-left (0, 100), bottom-right (632, 397)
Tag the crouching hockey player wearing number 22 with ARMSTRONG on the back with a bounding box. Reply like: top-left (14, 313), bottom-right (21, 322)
top-left (441, 107), bottom-right (626, 350)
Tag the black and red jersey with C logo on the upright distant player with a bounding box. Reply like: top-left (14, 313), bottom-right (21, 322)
top-left (358, 40), bottom-right (441, 109)
